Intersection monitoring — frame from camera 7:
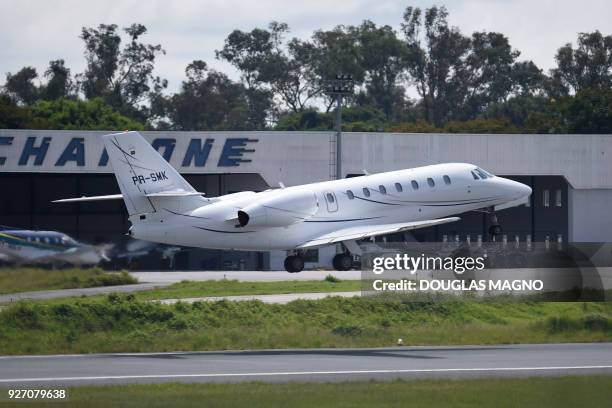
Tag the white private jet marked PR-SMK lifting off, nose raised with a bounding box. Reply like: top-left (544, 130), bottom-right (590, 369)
top-left (57, 132), bottom-right (531, 272)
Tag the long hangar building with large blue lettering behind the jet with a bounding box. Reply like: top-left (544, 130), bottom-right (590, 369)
top-left (0, 130), bottom-right (612, 269)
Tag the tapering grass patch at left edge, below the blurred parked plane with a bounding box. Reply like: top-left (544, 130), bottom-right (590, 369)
top-left (0, 267), bottom-right (138, 293)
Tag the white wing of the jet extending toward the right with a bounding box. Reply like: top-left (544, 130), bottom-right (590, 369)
top-left (297, 217), bottom-right (460, 248)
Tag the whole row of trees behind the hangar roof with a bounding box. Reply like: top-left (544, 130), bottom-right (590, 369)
top-left (0, 6), bottom-right (612, 133)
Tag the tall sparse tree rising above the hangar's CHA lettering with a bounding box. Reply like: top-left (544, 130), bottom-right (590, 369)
top-left (78, 24), bottom-right (167, 117)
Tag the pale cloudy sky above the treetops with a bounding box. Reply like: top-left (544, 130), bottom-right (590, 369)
top-left (0, 0), bottom-right (612, 91)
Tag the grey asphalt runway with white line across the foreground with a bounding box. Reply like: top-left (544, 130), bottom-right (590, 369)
top-left (0, 343), bottom-right (612, 387)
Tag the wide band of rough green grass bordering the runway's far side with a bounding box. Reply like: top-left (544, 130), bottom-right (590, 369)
top-left (0, 295), bottom-right (612, 355)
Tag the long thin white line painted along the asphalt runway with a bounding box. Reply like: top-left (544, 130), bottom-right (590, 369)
top-left (0, 365), bottom-right (612, 383)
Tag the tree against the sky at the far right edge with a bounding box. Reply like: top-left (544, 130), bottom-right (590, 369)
top-left (549, 31), bottom-right (612, 97)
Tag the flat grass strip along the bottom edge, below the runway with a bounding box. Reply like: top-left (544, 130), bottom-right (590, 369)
top-left (5, 376), bottom-right (612, 408)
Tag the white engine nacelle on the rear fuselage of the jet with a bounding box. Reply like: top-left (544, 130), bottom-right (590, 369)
top-left (238, 191), bottom-right (319, 228)
